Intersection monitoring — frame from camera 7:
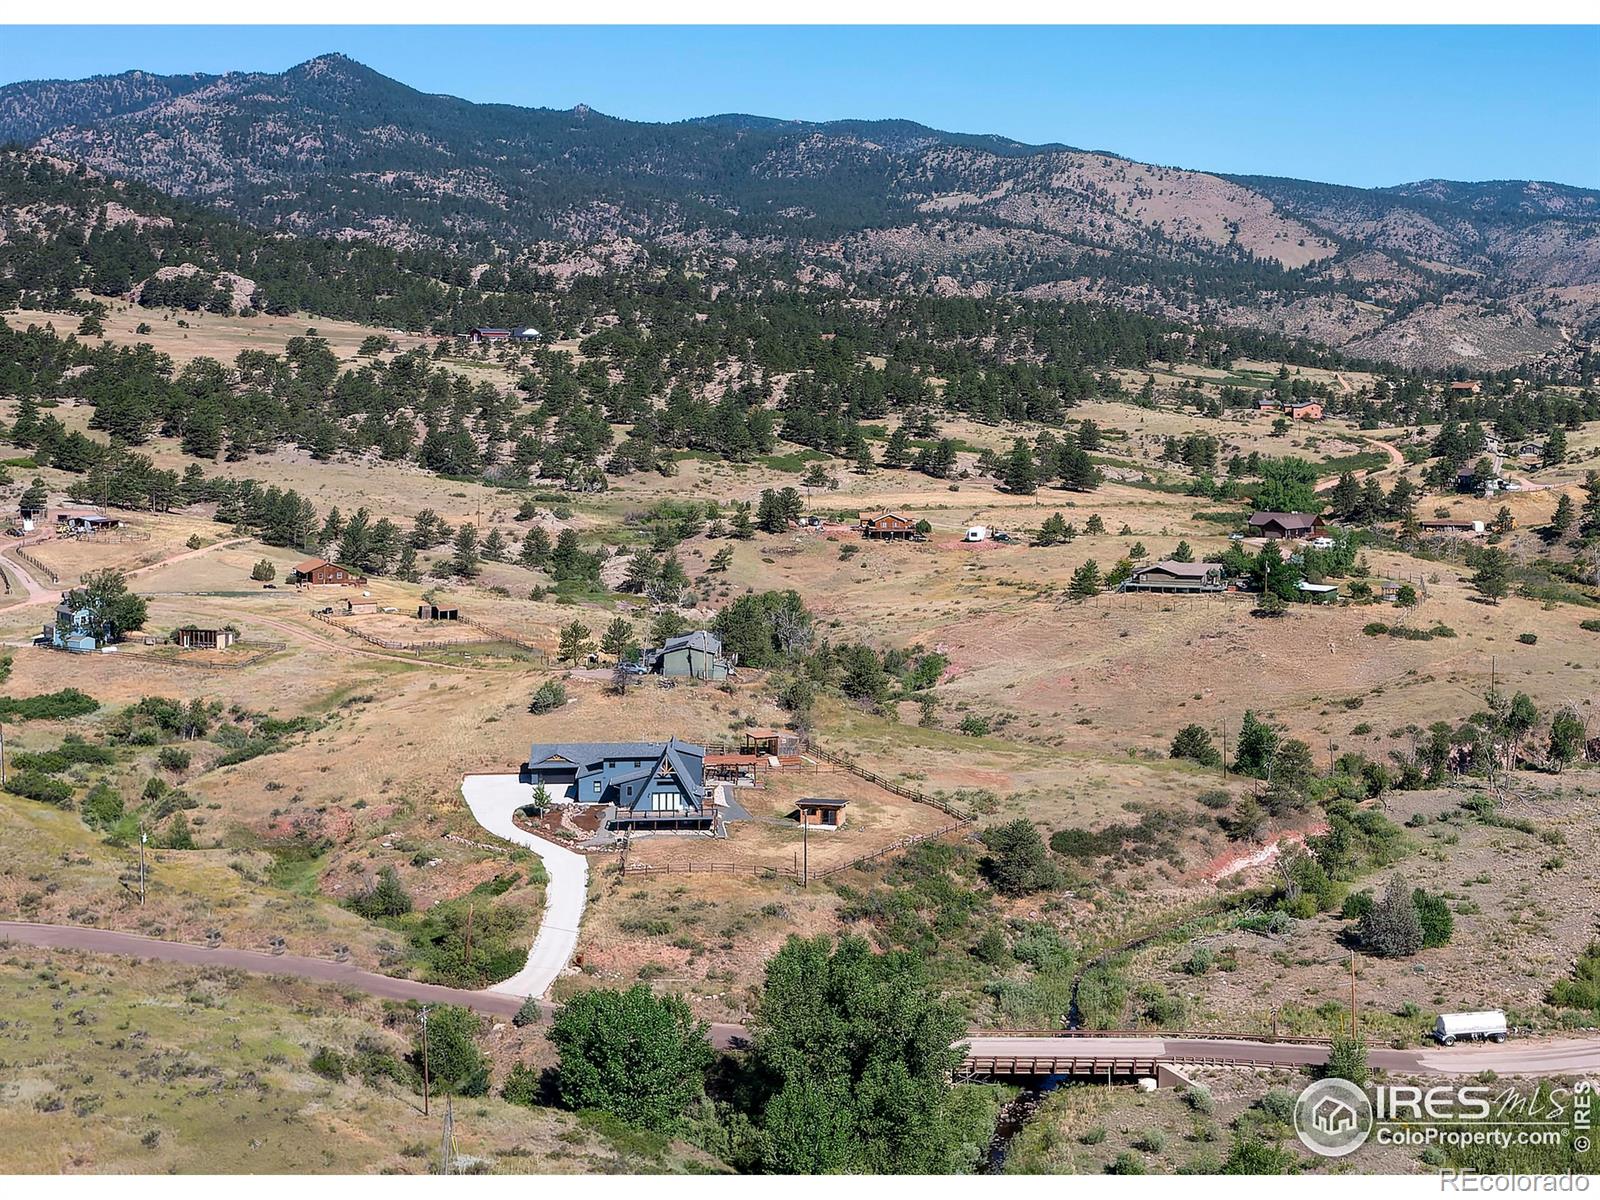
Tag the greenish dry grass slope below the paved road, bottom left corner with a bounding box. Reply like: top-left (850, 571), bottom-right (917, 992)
top-left (0, 947), bottom-right (717, 1174)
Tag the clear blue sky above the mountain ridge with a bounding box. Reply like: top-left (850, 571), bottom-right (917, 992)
top-left (0, 26), bottom-right (1600, 187)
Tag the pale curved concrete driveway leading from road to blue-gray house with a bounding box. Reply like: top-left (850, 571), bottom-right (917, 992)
top-left (461, 774), bottom-right (589, 995)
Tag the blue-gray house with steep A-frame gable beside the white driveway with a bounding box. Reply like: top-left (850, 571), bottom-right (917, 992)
top-left (523, 738), bottom-right (712, 829)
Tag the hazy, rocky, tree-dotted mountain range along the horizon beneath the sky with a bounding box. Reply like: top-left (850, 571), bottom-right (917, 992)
top-left (0, 56), bottom-right (1600, 368)
